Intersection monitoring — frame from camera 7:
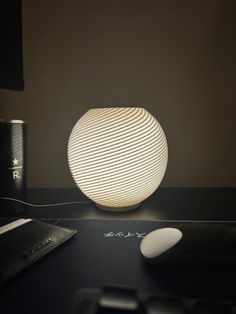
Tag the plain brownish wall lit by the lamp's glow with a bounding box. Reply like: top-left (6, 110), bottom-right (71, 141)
top-left (0, 0), bottom-right (236, 187)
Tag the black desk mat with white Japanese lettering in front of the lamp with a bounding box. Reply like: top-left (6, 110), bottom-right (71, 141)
top-left (0, 219), bottom-right (236, 314)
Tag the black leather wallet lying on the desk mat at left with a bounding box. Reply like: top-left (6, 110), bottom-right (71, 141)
top-left (0, 219), bottom-right (77, 284)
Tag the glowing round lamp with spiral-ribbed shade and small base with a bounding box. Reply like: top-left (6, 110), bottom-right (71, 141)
top-left (68, 107), bottom-right (168, 211)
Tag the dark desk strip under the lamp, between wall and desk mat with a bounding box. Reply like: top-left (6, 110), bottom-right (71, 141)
top-left (25, 188), bottom-right (236, 221)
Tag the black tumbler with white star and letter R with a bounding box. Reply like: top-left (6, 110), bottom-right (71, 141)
top-left (0, 120), bottom-right (27, 217)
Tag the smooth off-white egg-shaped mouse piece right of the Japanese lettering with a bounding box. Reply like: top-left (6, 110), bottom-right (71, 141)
top-left (140, 228), bottom-right (183, 259)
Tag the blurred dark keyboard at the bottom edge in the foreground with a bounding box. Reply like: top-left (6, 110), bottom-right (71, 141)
top-left (71, 287), bottom-right (236, 314)
